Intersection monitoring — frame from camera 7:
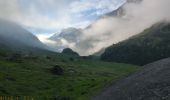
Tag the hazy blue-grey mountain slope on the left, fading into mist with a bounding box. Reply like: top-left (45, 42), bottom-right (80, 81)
top-left (0, 19), bottom-right (47, 51)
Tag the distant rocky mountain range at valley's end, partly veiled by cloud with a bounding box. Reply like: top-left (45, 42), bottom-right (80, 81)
top-left (49, 0), bottom-right (142, 55)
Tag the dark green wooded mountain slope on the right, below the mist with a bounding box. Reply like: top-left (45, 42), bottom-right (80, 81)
top-left (101, 23), bottom-right (170, 65)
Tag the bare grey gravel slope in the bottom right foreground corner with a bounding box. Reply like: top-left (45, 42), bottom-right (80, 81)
top-left (92, 58), bottom-right (170, 100)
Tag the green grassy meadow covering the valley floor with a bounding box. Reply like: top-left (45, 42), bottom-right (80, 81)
top-left (0, 56), bottom-right (139, 100)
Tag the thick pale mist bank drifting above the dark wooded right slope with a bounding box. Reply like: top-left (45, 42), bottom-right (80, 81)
top-left (72, 0), bottom-right (170, 55)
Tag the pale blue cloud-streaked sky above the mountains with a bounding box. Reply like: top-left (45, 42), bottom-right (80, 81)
top-left (0, 0), bottom-right (125, 36)
